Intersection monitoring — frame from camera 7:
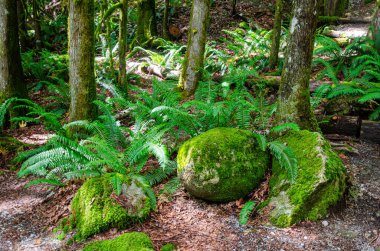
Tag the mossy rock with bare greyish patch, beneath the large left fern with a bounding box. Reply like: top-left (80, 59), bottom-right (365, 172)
top-left (71, 174), bottom-right (151, 239)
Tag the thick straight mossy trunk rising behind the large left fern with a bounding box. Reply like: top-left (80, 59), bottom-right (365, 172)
top-left (69, 0), bottom-right (96, 121)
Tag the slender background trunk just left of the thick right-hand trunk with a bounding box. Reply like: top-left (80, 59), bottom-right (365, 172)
top-left (269, 0), bottom-right (283, 69)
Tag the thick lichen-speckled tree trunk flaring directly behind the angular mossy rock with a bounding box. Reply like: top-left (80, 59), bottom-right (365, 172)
top-left (276, 0), bottom-right (318, 131)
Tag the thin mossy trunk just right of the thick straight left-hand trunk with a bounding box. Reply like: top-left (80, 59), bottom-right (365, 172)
top-left (118, 0), bottom-right (128, 91)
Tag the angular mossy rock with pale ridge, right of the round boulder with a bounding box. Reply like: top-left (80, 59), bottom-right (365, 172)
top-left (268, 130), bottom-right (346, 227)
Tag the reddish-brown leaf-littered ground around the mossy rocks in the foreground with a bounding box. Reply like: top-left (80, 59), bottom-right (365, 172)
top-left (0, 128), bottom-right (380, 251)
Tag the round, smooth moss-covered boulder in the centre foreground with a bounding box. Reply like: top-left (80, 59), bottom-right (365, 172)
top-left (177, 128), bottom-right (269, 202)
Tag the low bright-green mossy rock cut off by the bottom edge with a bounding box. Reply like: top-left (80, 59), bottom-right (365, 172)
top-left (83, 232), bottom-right (154, 251)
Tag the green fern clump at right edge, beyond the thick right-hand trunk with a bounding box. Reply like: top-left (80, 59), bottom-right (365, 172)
top-left (313, 36), bottom-right (380, 120)
